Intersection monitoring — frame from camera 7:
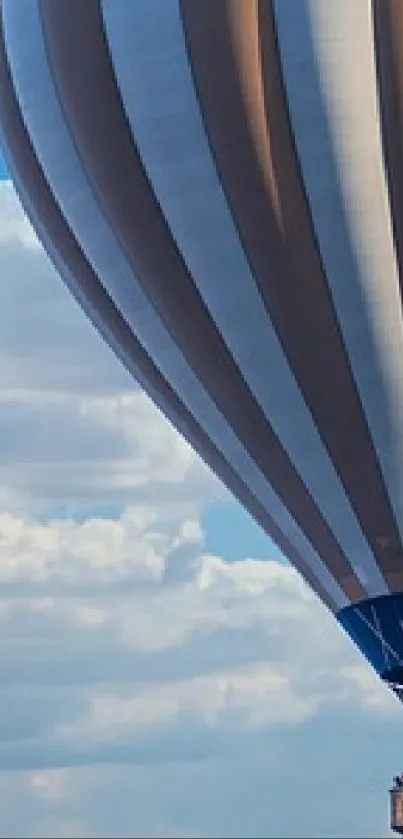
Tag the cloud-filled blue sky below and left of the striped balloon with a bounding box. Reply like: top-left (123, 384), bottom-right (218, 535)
top-left (0, 151), bottom-right (403, 838)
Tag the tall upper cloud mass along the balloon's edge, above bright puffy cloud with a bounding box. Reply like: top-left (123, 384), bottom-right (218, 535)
top-left (0, 183), bottom-right (219, 515)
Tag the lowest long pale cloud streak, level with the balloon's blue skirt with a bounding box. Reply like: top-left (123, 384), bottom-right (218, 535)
top-left (54, 663), bottom-right (324, 743)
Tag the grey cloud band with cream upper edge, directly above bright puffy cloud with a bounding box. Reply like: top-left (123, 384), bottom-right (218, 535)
top-left (0, 390), bottom-right (216, 509)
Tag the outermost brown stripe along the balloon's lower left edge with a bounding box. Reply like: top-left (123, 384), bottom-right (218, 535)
top-left (0, 13), bottom-right (344, 612)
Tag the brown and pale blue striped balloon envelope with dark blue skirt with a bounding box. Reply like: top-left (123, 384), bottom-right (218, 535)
top-left (0, 0), bottom-right (403, 695)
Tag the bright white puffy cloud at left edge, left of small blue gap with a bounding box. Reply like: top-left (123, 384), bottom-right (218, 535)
top-left (0, 503), bottom-right (202, 585)
